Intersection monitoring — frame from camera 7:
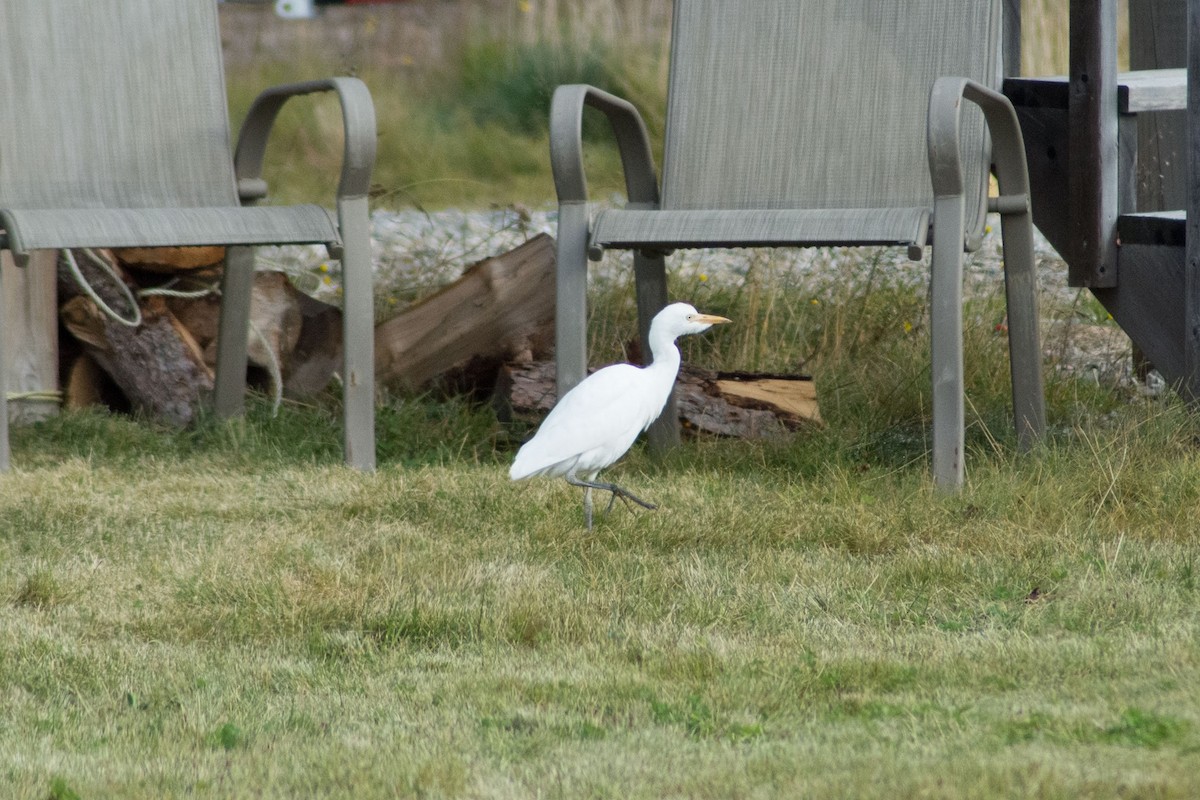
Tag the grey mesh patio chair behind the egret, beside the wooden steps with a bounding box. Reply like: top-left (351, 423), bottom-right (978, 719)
top-left (550, 0), bottom-right (1045, 487)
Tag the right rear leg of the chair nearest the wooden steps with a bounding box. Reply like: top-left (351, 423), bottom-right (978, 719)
top-left (1000, 212), bottom-right (1046, 450)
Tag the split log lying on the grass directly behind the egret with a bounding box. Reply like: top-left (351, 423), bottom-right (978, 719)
top-left (494, 361), bottom-right (822, 439)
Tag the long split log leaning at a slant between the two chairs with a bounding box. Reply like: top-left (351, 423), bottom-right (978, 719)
top-left (376, 234), bottom-right (554, 389)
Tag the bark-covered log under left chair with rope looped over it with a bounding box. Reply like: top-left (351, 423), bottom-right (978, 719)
top-left (60, 251), bottom-right (212, 426)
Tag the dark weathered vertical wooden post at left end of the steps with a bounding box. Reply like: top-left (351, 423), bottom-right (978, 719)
top-left (1064, 0), bottom-right (1118, 287)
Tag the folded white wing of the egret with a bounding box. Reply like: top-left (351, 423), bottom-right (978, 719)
top-left (509, 363), bottom-right (662, 480)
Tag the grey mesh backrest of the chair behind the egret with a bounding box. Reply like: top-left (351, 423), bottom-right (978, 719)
top-left (662, 0), bottom-right (1002, 237)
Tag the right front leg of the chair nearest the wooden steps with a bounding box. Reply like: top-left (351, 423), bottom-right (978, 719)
top-left (930, 196), bottom-right (965, 489)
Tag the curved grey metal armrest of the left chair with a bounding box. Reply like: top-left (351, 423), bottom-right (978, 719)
top-left (234, 78), bottom-right (376, 203)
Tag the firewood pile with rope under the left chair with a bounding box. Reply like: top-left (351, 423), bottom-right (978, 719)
top-left (59, 247), bottom-right (342, 426)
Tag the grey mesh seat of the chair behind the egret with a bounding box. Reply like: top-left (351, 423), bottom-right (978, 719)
top-left (590, 207), bottom-right (930, 248)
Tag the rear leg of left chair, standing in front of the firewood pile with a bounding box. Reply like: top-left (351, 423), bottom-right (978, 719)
top-left (214, 247), bottom-right (254, 419)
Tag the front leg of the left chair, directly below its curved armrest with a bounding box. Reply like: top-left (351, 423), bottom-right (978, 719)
top-left (337, 191), bottom-right (376, 471)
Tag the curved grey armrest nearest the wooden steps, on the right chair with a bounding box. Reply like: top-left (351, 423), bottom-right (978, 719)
top-left (928, 77), bottom-right (1030, 224)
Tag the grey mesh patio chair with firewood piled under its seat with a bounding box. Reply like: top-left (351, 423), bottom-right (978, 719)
top-left (0, 0), bottom-right (376, 470)
